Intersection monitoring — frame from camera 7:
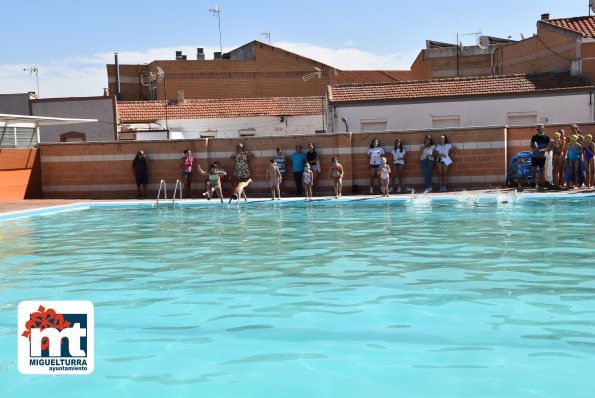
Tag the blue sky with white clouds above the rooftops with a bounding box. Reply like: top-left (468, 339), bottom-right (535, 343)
top-left (0, 0), bottom-right (589, 98)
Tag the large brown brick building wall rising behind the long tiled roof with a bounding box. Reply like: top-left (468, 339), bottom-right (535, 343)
top-left (107, 43), bottom-right (334, 101)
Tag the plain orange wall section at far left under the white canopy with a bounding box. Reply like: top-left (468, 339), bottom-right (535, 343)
top-left (0, 148), bottom-right (42, 200)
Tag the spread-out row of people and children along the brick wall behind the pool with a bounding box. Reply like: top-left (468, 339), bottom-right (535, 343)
top-left (132, 135), bottom-right (455, 205)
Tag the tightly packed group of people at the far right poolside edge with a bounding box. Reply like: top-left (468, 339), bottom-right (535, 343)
top-left (530, 124), bottom-right (595, 189)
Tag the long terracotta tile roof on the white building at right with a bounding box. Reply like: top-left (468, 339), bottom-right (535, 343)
top-left (330, 73), bottom-right (594, 103)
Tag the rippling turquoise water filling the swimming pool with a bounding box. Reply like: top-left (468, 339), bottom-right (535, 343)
top-left (0, 195), bottom-right (595, 397)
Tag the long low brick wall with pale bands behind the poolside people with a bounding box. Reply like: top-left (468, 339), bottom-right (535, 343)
top-left (40, 125), bottom-right (593, 198)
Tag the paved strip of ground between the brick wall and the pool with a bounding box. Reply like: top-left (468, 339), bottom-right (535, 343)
top-left (0, 188), bottom-right (595, 214)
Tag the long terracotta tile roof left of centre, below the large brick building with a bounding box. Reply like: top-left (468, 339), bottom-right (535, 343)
top-left (117, 97), bottom-right (323, 123)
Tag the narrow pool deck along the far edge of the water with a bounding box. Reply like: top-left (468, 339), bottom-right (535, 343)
top-left (0, 188), bottom-right (595, 214)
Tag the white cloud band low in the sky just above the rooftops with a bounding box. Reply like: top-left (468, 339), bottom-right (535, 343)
top-left (0, 42), bottom-right (419, 98)
